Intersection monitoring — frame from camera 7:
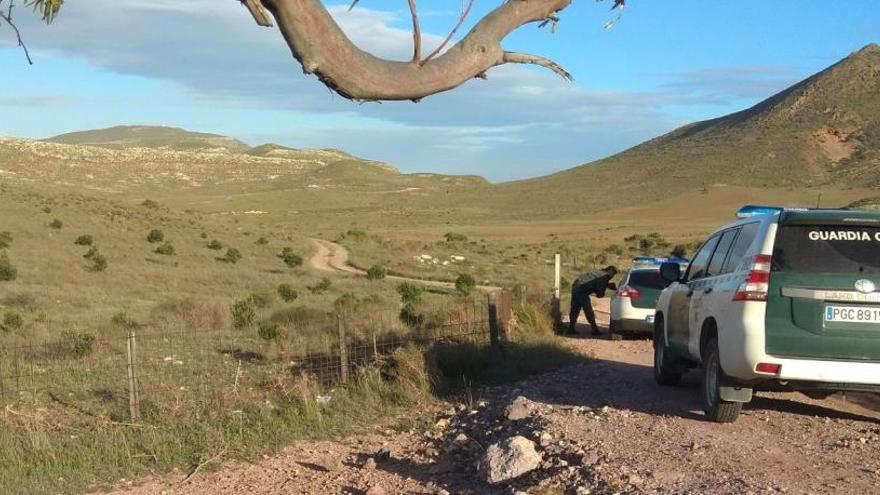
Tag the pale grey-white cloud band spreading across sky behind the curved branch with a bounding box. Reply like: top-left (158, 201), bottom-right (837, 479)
top-left (0, 0), bottom-right (784, 182)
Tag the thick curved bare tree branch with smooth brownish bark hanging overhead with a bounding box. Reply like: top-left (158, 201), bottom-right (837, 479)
top-left (241, 0), bottom-right (571, 101)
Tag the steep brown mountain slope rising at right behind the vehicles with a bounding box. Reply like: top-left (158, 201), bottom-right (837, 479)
top-left (499, 44), bottom-right (880, 209)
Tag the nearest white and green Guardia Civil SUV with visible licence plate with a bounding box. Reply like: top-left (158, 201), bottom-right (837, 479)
top-left (654, 206), bottom-right (880, 422)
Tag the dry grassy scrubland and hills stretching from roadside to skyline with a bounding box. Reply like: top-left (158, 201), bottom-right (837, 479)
top-left (0, 46), bottom-right (880, 493)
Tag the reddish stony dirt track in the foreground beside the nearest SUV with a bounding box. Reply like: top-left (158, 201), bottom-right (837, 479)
top-left (115, 306), bottom-right (880, 495)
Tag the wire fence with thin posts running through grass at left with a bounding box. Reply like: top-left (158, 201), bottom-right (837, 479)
top-left (0, 298), bottom-right (509, 421)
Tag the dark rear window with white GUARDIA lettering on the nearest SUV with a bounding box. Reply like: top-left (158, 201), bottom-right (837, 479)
top-left (772, 225), bottom-right (880, 273)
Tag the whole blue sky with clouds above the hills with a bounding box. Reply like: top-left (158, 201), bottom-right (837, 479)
top-left (0, 0), bottom-right (880, 181)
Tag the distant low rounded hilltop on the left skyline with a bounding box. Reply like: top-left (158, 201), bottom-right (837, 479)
top-left (45, 125), bottom-right (250, 153)
